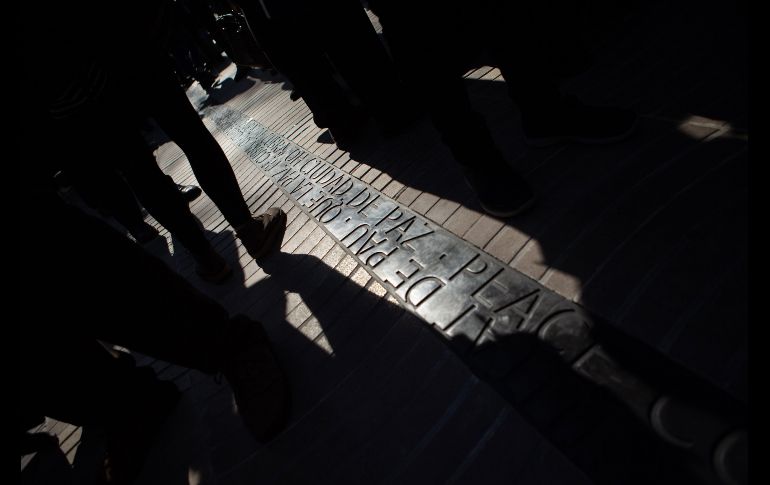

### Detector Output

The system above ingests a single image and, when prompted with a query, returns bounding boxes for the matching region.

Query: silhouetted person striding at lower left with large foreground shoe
[17,185,289,484]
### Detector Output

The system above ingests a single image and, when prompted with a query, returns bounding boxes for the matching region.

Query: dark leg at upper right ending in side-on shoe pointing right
[483,0,637,146]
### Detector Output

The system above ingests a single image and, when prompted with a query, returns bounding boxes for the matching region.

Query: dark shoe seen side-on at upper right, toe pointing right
[521,96,637,147]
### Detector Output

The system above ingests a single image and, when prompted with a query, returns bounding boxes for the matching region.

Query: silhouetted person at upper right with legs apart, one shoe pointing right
[368,0,636,217]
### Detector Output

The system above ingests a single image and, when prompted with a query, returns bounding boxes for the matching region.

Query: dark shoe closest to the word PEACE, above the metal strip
[465,166,535,218]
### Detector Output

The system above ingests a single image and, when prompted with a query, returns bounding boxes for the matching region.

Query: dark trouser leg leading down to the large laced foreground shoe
[20,190,228,372]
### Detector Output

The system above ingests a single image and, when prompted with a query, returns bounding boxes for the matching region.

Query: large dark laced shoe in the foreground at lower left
[222,315,289,442]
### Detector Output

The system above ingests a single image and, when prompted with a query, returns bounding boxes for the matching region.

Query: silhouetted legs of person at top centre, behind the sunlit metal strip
[236,0,407,148]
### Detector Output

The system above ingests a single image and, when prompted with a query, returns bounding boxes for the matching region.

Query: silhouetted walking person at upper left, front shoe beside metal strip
[25,2,286,282]
